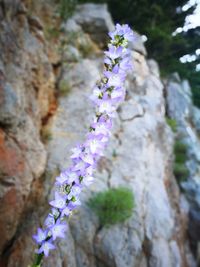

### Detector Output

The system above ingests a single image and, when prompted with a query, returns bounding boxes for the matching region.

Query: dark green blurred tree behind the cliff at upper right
[79,0,200,107]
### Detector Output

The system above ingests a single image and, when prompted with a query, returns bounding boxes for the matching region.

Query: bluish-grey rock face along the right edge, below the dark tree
[166,74,200,258]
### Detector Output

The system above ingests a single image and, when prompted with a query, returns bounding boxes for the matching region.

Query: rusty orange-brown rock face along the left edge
[0,1,54,265]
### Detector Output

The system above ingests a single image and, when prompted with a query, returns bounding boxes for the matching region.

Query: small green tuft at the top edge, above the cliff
[58,0,77,21]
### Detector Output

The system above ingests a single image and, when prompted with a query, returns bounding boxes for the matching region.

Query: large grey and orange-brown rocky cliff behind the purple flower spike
[0,0,199,267]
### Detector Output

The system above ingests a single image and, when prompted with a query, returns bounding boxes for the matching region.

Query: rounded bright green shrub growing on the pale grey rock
[88,187,135,226]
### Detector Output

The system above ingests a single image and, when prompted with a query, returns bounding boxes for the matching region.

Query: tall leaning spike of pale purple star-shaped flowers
[33,24,134,264]
